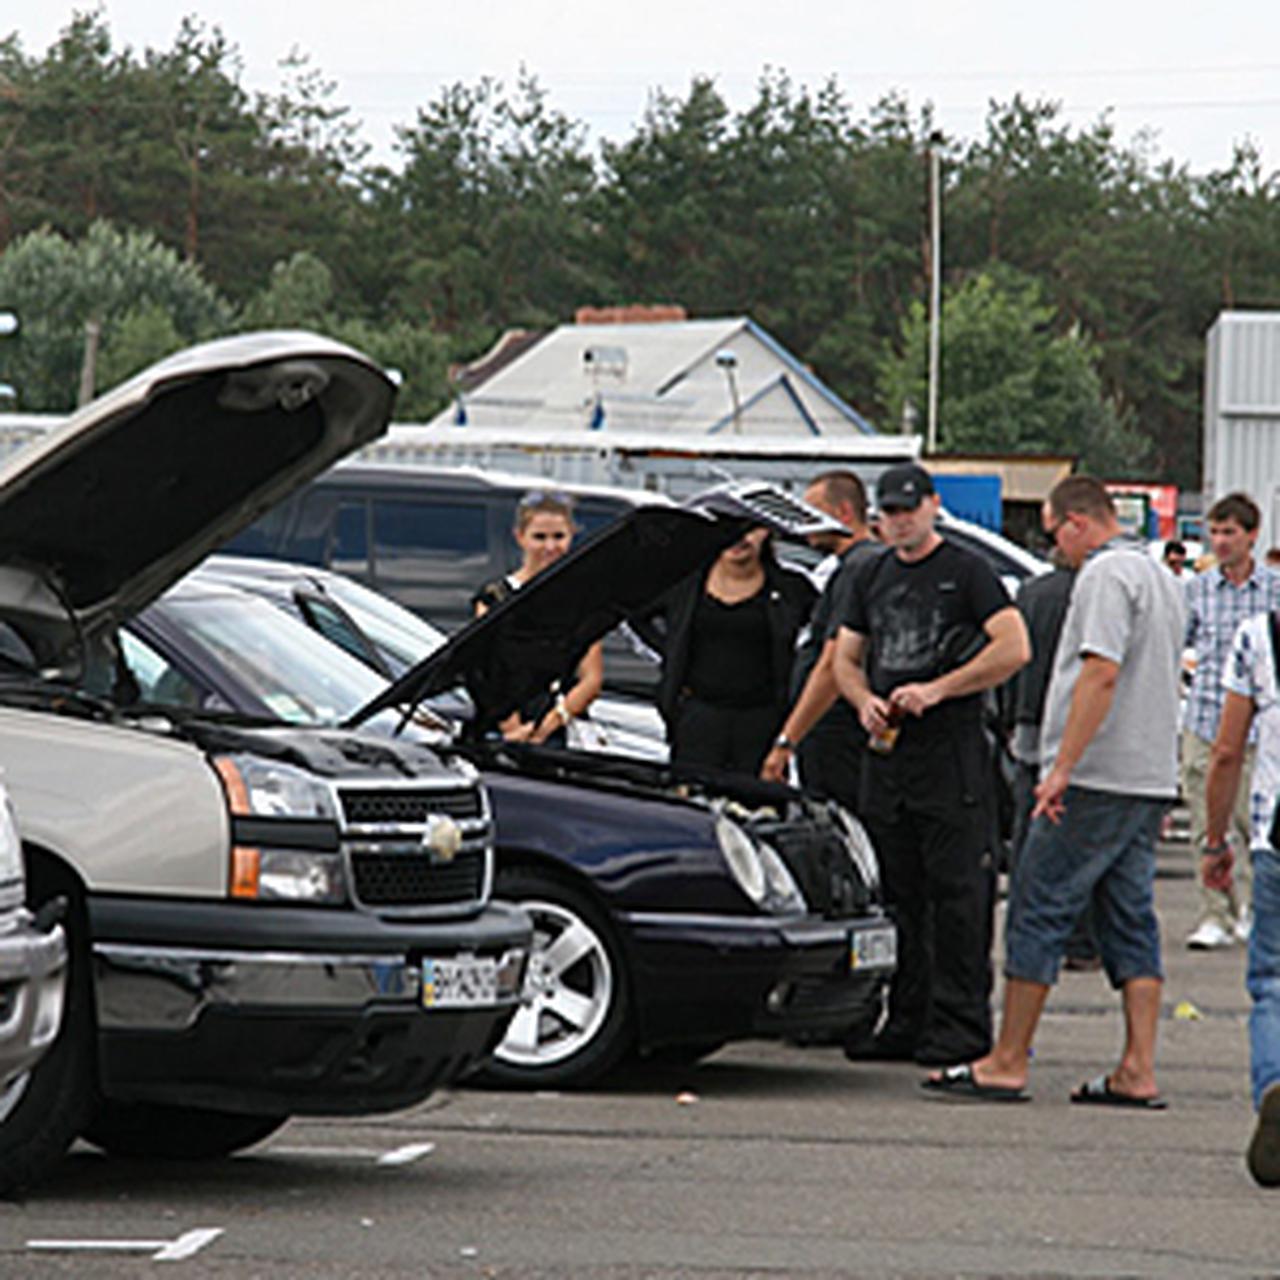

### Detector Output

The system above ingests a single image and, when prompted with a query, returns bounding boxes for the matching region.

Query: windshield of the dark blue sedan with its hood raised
[169,595,387,724]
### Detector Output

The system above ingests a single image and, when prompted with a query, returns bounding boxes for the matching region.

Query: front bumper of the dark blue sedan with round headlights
[625,911,893,1046]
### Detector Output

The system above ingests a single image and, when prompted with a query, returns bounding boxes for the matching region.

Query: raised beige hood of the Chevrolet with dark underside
[0,333,396,663]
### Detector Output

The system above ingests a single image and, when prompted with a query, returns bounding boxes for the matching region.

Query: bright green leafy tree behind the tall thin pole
[879,269,1147,476]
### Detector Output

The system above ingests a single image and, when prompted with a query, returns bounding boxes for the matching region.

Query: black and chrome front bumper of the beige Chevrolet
[90,899,531,1115]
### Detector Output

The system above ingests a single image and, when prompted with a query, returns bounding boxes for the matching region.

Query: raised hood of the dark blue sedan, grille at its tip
[348,483,844,726]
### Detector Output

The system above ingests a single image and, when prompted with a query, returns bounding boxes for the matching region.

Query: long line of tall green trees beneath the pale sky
[0,13,1280,488]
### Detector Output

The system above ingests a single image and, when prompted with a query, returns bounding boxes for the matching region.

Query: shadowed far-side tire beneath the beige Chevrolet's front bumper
[84,1102,288,1160]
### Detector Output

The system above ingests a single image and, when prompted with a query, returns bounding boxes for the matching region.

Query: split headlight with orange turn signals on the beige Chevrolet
[214,755,349,906]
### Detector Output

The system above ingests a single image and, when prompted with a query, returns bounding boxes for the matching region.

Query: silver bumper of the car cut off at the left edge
[0,908,67,1088]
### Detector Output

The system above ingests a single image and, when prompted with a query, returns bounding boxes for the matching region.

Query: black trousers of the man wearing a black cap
[860,718,996,1062]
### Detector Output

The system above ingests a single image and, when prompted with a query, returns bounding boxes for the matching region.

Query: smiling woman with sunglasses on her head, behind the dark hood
[471,490,604,746]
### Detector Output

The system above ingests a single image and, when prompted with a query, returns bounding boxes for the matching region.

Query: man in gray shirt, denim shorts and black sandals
[924,476,1183,1110]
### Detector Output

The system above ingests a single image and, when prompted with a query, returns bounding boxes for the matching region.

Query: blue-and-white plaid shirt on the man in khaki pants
[1183,564,1280,742]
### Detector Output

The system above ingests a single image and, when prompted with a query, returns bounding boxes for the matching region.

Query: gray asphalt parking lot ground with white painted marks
[0,845,1280,1280]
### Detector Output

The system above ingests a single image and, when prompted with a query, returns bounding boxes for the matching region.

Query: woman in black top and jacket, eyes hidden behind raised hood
[636,529,817,776]
